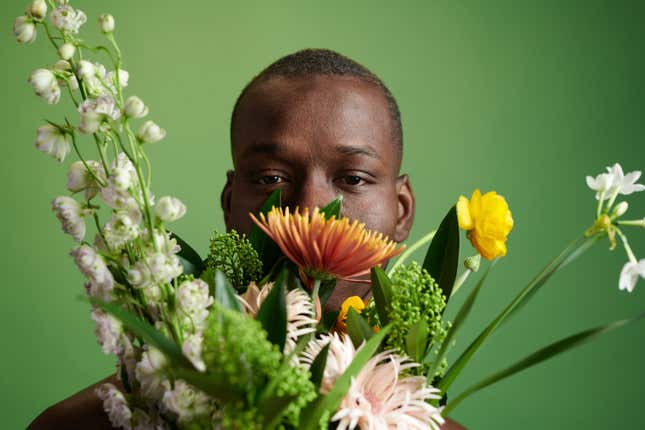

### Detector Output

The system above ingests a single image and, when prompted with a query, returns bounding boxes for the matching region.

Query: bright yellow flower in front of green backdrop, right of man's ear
[457,189,513,260]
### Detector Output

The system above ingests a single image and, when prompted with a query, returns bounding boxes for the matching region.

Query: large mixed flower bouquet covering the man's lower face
[14,0,645,429]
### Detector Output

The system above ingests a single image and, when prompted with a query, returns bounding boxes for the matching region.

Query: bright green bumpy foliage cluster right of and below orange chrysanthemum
[384,262,447,373]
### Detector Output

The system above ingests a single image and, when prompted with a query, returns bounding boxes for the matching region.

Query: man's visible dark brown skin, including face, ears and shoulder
[29,76,463,430]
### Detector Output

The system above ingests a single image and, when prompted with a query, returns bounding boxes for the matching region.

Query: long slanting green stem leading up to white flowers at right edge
[437,237,595,391]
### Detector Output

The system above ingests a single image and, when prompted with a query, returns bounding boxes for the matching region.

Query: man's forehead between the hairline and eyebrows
[232,75,397,166]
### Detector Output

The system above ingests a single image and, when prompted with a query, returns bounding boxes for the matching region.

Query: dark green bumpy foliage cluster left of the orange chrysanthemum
[206,230,262,292]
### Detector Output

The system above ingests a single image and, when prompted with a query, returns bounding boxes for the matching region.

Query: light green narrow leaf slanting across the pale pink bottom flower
[300,326,390,430]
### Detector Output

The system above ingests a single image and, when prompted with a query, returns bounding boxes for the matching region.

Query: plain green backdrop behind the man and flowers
[0,0,645,429]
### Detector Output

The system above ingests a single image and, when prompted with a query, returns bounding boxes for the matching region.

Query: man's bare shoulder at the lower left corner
[28,375,121,430]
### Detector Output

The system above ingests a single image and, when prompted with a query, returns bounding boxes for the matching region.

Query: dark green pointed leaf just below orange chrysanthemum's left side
[255,269,287,351]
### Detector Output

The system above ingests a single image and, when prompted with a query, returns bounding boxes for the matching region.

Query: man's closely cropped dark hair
[230,49,403,154]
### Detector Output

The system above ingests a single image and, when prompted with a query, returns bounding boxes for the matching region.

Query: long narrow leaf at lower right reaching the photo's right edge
[443,313,645,414]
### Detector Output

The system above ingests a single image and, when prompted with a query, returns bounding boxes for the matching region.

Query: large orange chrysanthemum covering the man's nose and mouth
[250,207,404,279]
